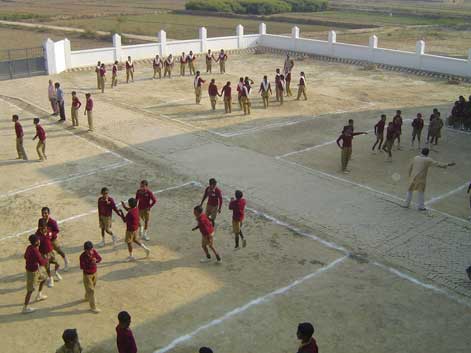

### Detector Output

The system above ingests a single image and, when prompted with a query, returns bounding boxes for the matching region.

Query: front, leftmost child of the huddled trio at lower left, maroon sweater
[23,234,47,314]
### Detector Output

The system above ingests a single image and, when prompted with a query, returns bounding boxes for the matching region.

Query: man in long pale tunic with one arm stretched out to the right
[403,148,456,211]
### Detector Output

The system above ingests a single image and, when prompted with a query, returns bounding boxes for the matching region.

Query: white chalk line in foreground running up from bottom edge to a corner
[154,256,348,353]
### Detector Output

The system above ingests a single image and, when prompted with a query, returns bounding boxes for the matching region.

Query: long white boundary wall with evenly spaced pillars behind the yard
[44,23,471,78]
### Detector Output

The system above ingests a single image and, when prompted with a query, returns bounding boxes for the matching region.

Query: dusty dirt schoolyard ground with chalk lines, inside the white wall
[0,54,471,353]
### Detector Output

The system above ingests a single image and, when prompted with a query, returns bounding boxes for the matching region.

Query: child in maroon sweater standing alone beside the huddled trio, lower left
[80,241,101,314]
